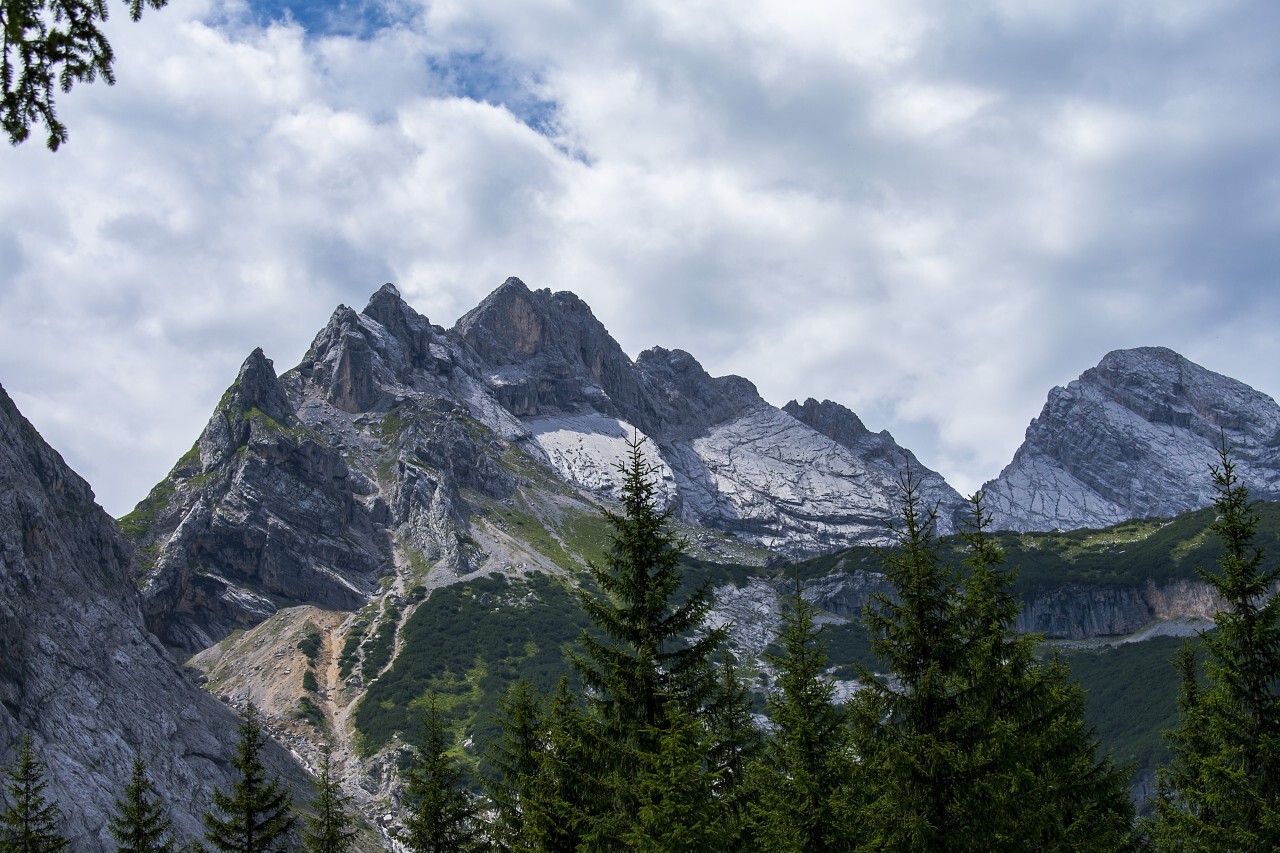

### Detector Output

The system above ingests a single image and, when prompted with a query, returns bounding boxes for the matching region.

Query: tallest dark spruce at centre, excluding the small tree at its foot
[571,438,742,849]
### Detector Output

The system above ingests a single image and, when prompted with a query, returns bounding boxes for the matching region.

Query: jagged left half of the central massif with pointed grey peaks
[135,284,519,653]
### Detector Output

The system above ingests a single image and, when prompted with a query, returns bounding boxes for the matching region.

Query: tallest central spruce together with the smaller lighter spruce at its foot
[571,439,739,849]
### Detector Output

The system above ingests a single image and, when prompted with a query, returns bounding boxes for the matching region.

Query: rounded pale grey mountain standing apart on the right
[983,347,1280,530]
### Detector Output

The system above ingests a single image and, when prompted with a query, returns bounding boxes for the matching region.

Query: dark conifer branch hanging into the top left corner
[0,0,166,151]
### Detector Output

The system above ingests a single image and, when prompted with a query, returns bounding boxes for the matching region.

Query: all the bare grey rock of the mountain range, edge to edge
[0,279,1280,839]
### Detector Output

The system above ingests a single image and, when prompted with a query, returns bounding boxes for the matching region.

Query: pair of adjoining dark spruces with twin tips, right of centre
[851,475,1134,850]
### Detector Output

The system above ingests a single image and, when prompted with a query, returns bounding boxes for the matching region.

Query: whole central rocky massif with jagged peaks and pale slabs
[129,278,960,653]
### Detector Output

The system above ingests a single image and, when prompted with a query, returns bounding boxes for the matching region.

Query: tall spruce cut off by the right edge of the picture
[1152,438,1280,850]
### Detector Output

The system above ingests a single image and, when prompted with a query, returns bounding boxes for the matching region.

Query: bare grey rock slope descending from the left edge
[0,388,308,850]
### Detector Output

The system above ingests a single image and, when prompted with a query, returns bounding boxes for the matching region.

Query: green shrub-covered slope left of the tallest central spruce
[355,575,588,752]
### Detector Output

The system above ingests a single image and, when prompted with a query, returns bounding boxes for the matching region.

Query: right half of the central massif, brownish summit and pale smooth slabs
[452,279,959,555]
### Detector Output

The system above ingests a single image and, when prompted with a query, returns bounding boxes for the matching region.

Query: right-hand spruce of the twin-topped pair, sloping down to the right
[951,494,1135,850]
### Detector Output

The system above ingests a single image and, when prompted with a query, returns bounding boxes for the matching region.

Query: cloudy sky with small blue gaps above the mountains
[0,0,1280,515]
